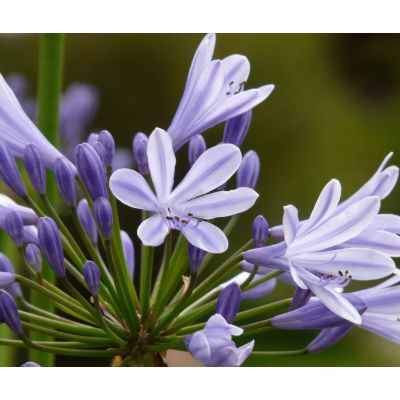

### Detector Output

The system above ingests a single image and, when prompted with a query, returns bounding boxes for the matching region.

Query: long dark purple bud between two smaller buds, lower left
[37,217,65,278]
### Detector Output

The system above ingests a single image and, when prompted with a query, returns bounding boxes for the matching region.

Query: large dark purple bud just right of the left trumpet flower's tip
[75,143,107,200]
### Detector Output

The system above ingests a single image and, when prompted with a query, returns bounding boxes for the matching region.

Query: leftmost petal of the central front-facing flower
[110,168,158,212]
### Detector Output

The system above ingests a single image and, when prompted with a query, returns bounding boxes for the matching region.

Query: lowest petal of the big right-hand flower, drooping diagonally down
[307,282,362,325]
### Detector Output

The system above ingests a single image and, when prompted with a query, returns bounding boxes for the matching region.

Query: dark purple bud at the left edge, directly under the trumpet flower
[0,140,27,197]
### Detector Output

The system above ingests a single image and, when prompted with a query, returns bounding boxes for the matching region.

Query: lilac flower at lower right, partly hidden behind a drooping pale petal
[272,276,400,352]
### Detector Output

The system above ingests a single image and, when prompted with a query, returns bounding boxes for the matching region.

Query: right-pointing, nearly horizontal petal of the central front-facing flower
[182,188,258,219]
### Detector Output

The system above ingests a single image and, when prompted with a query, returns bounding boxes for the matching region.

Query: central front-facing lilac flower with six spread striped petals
[110,128,258,253]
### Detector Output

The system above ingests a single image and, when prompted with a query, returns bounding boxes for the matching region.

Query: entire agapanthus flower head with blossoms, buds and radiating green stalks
[0,34,400,367]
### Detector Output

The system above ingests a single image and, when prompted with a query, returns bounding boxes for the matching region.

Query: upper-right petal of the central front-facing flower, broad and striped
[171,144,242,204]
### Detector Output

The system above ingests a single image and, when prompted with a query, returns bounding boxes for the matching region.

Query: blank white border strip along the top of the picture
[0,0,399,33]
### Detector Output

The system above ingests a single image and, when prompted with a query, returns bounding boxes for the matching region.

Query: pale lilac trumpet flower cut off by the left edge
[0,74,75,170]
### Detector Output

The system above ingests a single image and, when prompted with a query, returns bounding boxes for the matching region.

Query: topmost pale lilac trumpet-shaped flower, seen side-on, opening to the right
[168,34,274,150]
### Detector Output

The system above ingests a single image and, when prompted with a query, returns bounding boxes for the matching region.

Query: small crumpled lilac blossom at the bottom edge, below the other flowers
[184,314,254,367]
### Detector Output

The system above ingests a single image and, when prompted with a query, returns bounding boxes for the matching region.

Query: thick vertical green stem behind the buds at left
[29,33,64,367]
